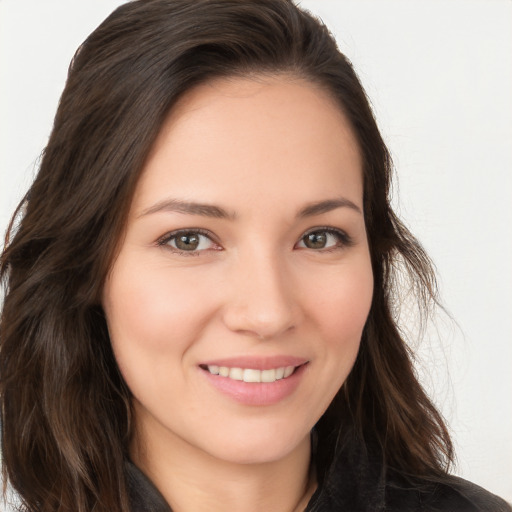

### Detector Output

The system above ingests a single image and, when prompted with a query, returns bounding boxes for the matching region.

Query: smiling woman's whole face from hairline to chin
[103,77,373,463]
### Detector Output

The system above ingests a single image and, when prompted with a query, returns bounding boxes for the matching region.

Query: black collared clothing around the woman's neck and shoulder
[126,436,512,512]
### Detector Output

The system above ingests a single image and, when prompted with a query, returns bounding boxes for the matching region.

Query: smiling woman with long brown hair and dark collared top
[0,0,509,511]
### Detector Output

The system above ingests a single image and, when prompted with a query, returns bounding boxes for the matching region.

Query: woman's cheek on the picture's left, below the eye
[103,255,216,366]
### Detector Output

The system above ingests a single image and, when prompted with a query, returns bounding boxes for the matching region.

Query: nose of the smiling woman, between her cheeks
[223,248,301,339]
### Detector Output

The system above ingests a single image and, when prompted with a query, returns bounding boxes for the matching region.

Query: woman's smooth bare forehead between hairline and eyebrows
[134,76,362,213]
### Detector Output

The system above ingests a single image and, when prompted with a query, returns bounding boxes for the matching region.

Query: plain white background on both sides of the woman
[0,0,512,501]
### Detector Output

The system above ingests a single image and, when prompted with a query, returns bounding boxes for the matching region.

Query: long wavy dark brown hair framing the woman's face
[0,0,452,512]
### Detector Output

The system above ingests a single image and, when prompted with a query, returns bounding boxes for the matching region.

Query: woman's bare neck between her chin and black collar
[131,412,315,512]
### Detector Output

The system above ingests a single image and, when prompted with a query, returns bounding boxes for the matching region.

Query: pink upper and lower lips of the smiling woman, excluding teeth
[199,358,309,406]
